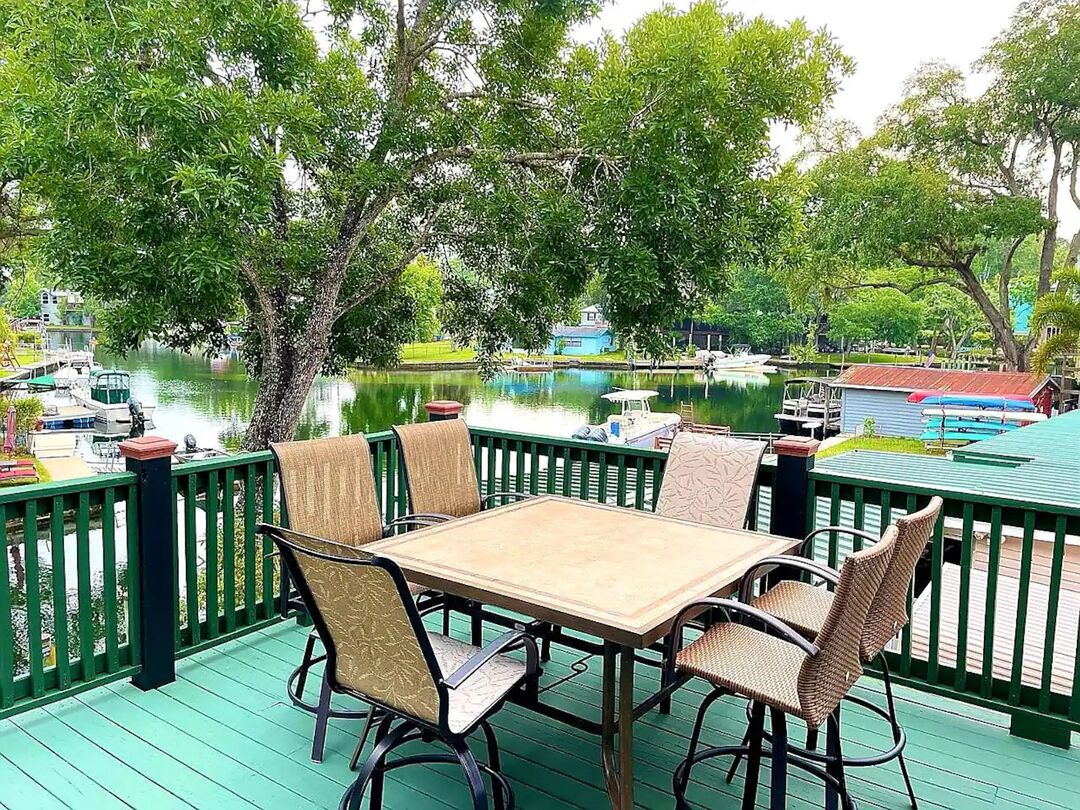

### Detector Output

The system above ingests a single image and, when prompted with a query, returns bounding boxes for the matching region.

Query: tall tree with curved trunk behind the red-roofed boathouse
[808,0,1080,368]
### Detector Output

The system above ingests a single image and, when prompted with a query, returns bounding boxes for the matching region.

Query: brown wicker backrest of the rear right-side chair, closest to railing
[862,496,942,661]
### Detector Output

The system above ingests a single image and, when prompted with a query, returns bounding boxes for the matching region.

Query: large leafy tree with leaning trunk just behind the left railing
[0,0,848,448]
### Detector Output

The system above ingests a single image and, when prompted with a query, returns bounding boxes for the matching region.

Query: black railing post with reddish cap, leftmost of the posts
[120,436,176,690]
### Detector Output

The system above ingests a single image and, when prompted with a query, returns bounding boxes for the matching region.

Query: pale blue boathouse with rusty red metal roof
[832,365,1057,437]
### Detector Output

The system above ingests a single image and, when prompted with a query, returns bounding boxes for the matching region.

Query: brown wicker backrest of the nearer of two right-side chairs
[798,526,897,727]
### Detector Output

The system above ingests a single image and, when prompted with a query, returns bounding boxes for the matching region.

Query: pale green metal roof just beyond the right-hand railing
[818,411,1080,509]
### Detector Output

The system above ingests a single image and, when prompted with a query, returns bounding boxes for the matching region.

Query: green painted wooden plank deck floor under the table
[0,622,1080,810]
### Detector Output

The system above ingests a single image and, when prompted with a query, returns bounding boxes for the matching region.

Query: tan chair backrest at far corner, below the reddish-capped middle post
[394,419,481,517]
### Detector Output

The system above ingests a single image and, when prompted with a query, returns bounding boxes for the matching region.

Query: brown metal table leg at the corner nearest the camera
[600,642,634,810]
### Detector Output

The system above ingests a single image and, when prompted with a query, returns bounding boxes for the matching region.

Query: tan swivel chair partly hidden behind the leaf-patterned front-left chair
[270,435,441,762]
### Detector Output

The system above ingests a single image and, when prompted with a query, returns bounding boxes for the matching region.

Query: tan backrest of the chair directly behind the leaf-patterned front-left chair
[270,435,382,545]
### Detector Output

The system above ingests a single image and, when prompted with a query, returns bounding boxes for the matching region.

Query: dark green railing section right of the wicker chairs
[808,468,1080,745]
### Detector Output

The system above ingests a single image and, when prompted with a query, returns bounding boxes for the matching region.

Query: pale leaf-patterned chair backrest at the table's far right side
[656,432,765,529]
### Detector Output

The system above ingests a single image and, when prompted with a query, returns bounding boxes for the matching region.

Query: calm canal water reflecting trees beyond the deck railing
[100,345,803,449]
